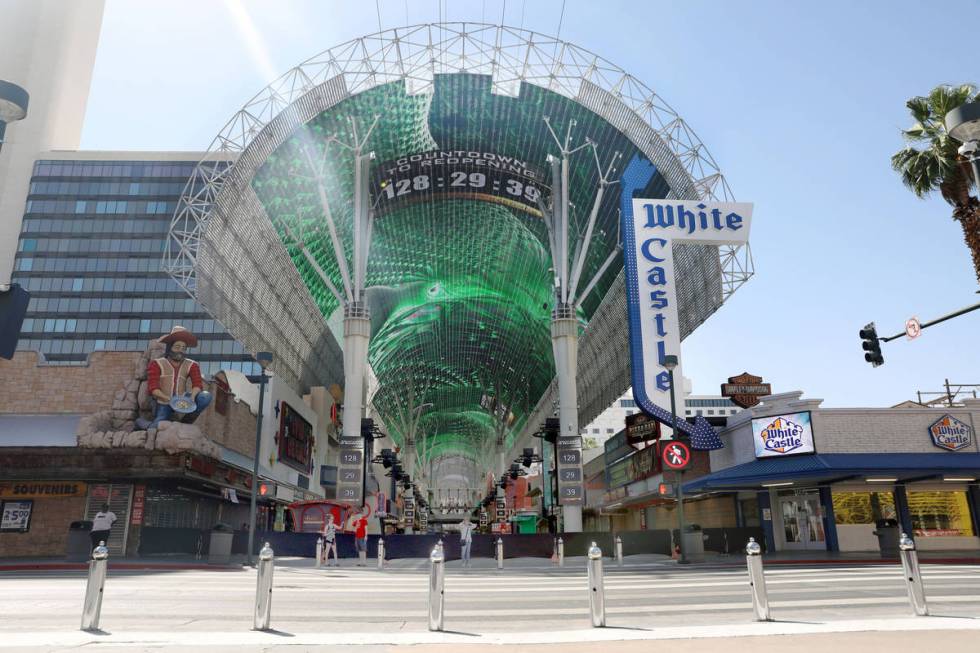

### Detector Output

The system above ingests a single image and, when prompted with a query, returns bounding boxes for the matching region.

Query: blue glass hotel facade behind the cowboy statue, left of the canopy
[13,160,258,375]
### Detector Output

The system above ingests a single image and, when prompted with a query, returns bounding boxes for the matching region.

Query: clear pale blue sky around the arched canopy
[82,0,980,406]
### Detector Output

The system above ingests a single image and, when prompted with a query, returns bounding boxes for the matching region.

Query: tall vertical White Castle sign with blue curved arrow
[620,155,752,449]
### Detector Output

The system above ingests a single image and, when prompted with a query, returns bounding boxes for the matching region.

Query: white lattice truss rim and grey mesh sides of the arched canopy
[164,23,754,398]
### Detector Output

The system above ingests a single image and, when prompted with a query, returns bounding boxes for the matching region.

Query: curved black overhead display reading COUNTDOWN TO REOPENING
[373,150,548,217]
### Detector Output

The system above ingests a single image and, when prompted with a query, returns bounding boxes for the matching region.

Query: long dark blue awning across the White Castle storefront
[684,453,980,494]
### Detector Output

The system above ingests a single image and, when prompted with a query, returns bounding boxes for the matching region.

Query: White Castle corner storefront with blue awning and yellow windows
[685,392,980,551]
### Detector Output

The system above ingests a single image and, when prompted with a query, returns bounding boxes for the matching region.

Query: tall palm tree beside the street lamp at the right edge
[892,84,980,282]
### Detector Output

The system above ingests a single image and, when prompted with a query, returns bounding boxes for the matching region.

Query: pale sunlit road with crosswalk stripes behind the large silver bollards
[0,561,980,652]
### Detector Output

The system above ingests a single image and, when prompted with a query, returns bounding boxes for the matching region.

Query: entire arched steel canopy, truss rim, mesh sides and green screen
[165,23,752,484]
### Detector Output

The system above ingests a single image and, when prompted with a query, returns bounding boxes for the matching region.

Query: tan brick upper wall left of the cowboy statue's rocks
[0,351,140,414]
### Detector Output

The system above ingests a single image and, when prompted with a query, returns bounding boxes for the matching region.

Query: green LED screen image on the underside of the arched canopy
[253,74,668,463]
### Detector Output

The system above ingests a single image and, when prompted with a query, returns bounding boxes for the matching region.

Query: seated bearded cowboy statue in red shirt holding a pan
[136,326,211,430]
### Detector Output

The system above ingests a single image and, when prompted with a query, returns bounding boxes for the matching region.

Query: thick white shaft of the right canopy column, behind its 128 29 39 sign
[551,304,582,533]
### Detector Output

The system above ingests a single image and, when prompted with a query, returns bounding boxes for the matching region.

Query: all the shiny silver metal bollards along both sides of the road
[82,533,929,631]
